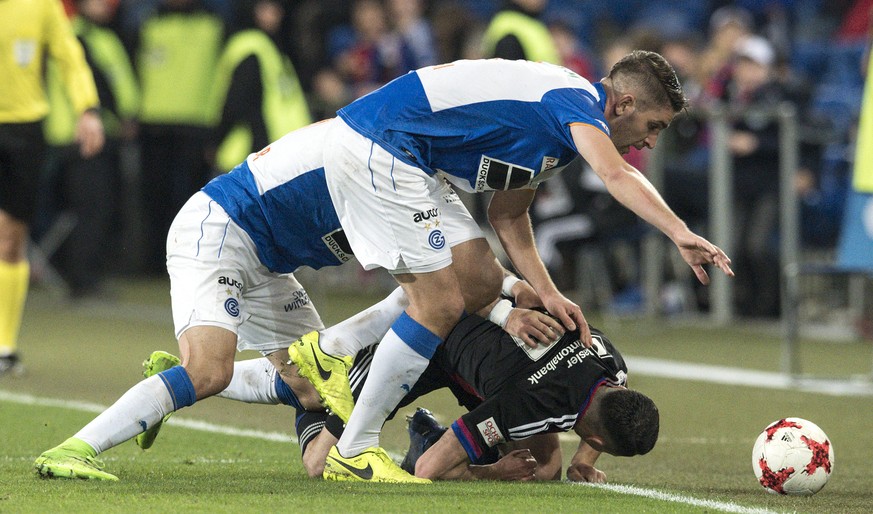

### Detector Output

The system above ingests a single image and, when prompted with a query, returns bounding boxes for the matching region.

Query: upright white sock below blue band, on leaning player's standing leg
[337,330,430,457]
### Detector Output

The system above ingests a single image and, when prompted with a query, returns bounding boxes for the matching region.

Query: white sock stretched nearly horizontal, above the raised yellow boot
[318,287,409,357]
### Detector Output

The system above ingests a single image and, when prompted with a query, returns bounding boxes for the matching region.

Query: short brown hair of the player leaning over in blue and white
[606,50,688,113]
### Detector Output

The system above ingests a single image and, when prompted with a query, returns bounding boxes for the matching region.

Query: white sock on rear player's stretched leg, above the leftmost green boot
[73,375,173,453]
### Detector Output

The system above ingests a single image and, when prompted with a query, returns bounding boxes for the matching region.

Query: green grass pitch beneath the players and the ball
[0,281,873,513]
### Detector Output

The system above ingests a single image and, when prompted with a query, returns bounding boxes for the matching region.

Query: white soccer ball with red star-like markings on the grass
[752,418,834,496]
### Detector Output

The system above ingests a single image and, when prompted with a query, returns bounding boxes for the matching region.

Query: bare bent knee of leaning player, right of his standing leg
[452,237,503,312]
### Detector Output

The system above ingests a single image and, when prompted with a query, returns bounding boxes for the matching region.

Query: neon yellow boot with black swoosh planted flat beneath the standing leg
[322,446,431,484]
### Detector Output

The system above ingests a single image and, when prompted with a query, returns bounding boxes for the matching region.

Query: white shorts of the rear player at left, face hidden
[167,192,324,355]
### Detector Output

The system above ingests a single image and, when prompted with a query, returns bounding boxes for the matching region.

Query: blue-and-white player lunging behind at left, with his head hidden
[35,121,503,480]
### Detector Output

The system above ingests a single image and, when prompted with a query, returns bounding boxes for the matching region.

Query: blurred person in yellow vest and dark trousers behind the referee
[40,0,139,298]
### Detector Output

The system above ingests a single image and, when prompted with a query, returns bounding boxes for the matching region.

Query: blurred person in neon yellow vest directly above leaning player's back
[482,0,561,64]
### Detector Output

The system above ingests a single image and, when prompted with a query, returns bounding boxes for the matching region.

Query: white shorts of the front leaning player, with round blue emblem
[324,118,485,274]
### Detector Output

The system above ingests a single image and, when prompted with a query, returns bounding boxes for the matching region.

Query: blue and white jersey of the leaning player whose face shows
[338,59,609,192]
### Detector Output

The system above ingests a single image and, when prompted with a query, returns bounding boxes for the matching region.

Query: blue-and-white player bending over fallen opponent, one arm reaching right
[289,51,733,481]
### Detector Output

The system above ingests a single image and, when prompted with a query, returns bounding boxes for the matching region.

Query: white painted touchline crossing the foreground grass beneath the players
[8,389,775,514]
